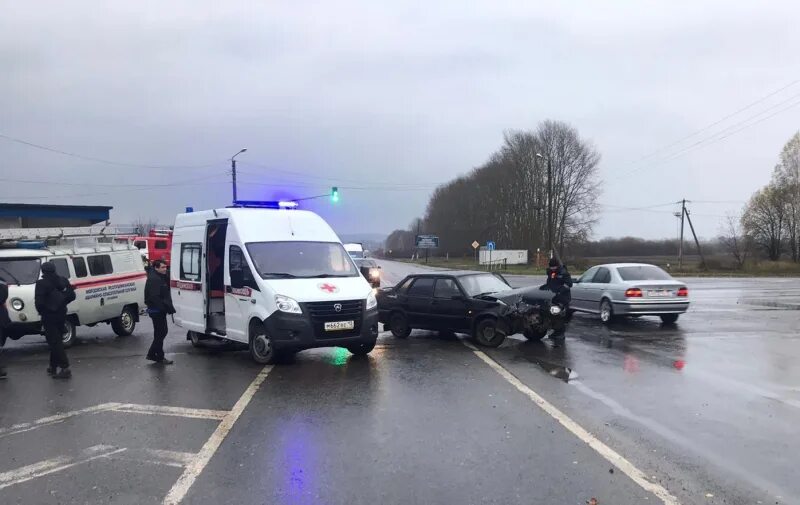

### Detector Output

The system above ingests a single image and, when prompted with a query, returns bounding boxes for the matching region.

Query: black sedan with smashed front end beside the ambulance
[377,271,512,347]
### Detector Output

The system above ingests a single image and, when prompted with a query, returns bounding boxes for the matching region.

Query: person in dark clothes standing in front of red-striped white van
[34,262,75,379]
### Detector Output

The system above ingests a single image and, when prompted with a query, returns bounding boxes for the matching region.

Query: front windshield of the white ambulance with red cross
[247,242,359,279]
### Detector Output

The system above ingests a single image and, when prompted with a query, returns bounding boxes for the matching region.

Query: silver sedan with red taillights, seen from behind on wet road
[571,263,689,324]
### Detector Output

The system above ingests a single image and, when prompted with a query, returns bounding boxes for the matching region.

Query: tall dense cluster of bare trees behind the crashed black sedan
[386,121,600,255]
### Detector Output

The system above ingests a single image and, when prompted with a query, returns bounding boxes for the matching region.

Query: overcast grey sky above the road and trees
[0,0,800,238]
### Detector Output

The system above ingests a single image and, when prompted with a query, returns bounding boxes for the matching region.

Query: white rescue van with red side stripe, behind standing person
[0,241,147,347]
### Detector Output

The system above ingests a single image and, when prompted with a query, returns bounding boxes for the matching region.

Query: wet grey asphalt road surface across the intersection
[0,262,800,505]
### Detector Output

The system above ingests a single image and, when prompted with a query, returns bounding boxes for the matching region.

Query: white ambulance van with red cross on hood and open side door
[170,207,378,363]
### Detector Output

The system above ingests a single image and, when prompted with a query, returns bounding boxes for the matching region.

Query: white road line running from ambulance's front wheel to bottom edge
[164,365,272,505]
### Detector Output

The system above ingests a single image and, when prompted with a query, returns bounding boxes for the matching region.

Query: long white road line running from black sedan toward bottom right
[464,342,680,505]
